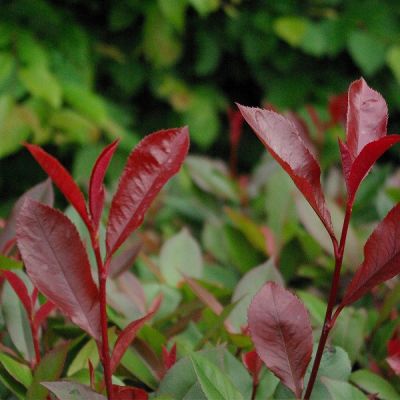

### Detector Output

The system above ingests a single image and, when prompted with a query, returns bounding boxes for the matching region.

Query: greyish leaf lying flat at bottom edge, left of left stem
[42,381,106,400]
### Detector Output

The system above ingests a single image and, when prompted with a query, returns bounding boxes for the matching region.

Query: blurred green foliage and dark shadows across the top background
[0,0,400,212]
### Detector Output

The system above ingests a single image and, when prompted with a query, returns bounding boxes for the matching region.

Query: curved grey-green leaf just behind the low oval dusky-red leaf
[229,260,284,332]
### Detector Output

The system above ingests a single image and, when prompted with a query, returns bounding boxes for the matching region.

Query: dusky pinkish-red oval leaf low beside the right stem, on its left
[248,282,313,398]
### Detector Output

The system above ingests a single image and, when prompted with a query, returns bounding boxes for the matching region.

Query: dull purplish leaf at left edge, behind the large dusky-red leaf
[0,179,54,254]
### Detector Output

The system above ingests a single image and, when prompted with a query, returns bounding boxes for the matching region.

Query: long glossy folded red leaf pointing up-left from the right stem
[238,105,335,237]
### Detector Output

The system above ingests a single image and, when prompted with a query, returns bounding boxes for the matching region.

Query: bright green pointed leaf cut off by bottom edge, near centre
[191,354,243,400]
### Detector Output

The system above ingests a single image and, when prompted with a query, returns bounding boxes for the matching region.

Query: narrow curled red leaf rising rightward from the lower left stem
[110,296,162,373]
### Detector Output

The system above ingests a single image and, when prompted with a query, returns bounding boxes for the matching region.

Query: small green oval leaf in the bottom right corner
[350,369,400,400]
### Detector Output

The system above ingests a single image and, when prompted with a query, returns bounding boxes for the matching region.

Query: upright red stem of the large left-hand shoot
[92,237,113,400]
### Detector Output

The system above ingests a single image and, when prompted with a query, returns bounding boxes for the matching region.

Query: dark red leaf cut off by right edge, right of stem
[339,204,400,310]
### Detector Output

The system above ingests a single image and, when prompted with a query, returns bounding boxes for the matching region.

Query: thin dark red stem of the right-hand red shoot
[304,200,353,400]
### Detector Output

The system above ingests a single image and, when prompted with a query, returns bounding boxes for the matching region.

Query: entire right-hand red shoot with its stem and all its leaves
[239,78,400,400]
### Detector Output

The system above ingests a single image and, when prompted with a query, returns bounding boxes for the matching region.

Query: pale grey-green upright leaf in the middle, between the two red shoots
[160,229,203,286]
